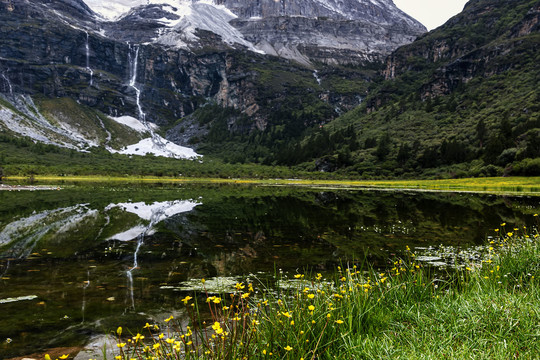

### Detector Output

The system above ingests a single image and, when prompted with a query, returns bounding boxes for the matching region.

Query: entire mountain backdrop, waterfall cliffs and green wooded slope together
[0,0,540,177]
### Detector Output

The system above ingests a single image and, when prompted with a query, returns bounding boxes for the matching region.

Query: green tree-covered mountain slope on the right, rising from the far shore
[292,0,540,177]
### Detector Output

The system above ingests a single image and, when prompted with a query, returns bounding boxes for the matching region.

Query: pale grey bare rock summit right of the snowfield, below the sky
[216,0,426,65]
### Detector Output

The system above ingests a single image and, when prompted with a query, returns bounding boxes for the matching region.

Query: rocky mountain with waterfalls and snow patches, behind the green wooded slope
[0,0,425,162]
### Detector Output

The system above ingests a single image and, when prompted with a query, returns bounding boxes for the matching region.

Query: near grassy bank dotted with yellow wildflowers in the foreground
[90,221,540,360]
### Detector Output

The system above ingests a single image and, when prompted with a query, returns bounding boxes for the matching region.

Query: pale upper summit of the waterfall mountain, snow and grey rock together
[85,0,426,65]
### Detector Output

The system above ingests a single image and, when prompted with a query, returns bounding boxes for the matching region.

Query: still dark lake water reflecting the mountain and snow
[0,184,540,359]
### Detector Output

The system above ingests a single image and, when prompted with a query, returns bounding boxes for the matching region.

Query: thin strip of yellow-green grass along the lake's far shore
[4,175,540,195]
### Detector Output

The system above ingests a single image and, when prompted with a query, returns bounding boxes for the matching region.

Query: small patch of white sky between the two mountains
[393,0,467,30]
